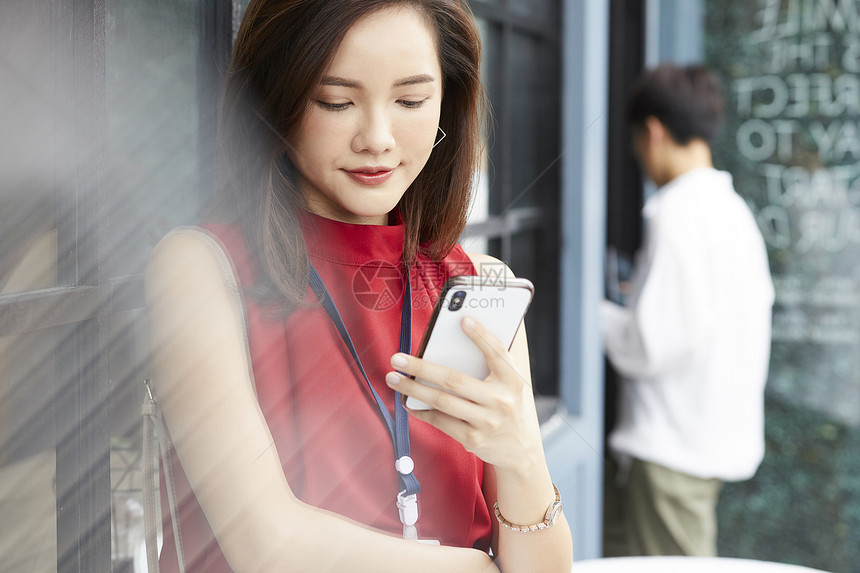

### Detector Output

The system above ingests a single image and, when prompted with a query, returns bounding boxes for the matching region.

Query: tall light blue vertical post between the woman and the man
[559,0,609,559]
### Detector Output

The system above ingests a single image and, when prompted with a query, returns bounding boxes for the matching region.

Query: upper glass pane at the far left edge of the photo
[0,0,62,293]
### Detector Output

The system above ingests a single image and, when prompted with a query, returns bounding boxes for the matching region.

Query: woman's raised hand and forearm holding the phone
[386,298,573,572]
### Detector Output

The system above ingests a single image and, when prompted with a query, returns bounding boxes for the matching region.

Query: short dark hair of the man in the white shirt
[627,64,723,145]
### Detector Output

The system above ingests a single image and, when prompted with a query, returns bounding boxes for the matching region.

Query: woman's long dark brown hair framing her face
[210,0,484,313]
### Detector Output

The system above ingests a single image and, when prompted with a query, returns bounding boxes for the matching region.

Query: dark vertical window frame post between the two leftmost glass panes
[55,0,111,573]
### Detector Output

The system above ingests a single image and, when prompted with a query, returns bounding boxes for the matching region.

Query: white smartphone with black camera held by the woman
[406,276,534,410]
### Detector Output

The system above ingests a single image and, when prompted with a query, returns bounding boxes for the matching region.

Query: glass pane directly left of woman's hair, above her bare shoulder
[106,0,202,276]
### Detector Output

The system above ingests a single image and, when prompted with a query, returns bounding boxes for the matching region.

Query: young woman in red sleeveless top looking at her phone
[146,0,571,573]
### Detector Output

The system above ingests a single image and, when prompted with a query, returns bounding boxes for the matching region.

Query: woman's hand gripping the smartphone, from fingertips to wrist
[386,318,543,471]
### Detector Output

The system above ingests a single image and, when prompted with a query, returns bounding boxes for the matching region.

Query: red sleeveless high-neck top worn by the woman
[160,215,491,573]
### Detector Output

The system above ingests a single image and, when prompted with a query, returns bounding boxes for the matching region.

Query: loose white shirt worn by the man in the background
[601,168,774,481]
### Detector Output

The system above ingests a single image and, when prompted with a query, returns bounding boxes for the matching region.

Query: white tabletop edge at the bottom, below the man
[573,557,821,573]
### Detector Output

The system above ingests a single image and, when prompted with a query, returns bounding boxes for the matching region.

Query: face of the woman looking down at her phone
[288,8,444,225]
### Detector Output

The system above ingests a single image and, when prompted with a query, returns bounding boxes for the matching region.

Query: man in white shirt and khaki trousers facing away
[601,64,774,556]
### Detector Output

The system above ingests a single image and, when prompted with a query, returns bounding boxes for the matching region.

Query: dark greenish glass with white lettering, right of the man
[704,0,860,571]
